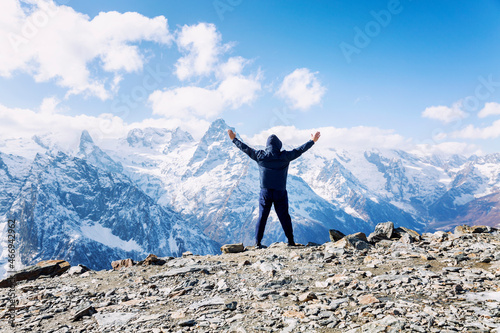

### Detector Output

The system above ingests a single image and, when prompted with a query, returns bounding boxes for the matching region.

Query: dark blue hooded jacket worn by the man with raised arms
[233,134,314,190]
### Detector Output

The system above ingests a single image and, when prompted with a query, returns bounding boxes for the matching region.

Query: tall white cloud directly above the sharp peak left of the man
[152,23,261,120]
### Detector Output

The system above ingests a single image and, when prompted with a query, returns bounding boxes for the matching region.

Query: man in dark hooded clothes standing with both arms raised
[227,130,320,249]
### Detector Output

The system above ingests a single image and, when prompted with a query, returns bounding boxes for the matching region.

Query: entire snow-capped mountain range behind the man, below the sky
[0,119,500,276]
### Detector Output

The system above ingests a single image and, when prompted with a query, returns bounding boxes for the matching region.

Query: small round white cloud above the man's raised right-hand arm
[276,68,326,110]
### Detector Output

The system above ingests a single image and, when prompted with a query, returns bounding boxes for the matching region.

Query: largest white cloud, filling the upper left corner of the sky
[0,0,172,99]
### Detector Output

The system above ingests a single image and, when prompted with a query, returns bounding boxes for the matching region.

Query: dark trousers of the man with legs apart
[255,188,293,244]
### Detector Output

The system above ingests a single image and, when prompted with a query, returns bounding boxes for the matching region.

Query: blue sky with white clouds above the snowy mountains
[0,0,500,153]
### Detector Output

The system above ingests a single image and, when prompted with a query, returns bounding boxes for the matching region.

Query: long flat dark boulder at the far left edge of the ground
[0,260,71,288]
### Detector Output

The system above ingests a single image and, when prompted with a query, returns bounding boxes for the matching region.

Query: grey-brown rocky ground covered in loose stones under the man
[0,224,500,333]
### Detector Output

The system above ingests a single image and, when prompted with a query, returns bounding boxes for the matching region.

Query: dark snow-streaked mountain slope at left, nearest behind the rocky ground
[2,152,218,269]
